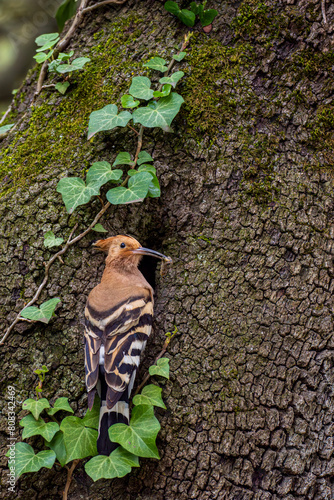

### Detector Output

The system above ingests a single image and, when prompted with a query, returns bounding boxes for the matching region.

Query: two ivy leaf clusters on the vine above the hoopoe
[57,51,186,214]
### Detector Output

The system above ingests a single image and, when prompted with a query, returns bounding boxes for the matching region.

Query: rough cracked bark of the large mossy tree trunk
[0,0,334,500]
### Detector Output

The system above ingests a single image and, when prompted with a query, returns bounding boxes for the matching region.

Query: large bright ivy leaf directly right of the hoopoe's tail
[109,404,160,459]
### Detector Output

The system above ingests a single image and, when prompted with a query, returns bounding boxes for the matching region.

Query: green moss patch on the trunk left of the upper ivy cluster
[0,15,146,193]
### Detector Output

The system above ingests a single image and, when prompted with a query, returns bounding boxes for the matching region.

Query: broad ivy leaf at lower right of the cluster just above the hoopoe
[107,172,152,205]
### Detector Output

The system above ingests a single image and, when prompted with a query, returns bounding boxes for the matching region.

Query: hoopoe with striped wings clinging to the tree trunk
[84,235,171,456]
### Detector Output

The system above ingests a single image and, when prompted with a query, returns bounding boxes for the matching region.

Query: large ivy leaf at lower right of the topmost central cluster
[133,92,184,131]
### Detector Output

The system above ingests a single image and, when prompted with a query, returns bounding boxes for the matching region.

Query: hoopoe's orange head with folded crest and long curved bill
[93,235,171,266]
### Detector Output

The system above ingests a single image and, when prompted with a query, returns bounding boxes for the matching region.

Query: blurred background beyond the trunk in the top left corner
[0,0,63,113]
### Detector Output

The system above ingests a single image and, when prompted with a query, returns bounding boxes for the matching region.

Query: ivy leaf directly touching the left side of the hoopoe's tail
[60,417,98,463]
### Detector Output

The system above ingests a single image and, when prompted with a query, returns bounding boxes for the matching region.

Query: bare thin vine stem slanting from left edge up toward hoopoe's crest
[0,197,111,345]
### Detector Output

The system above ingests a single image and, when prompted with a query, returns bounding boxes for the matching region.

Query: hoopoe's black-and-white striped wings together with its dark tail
[85,290,153,455]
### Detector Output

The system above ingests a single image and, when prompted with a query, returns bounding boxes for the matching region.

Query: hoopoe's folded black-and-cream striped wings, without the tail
[85,290,153,408]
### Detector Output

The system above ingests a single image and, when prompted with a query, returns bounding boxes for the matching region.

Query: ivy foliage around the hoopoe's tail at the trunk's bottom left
[7,358,169,481]
